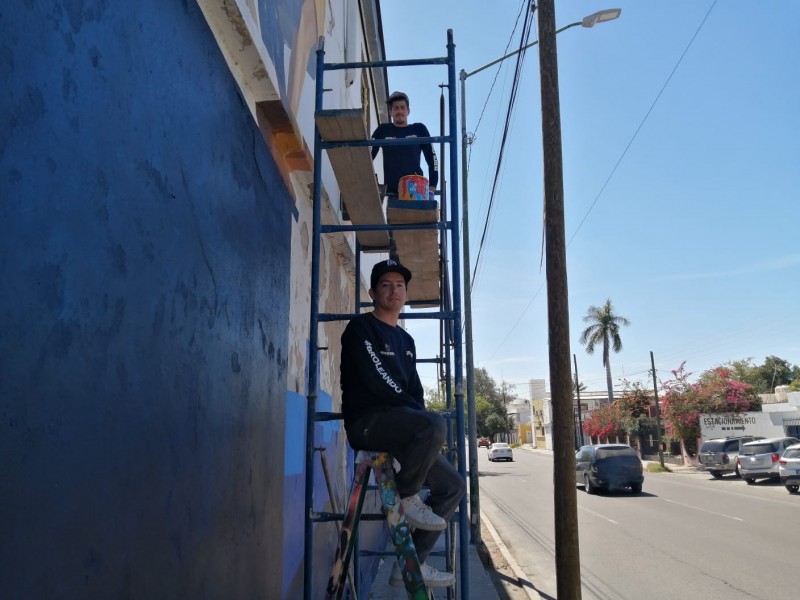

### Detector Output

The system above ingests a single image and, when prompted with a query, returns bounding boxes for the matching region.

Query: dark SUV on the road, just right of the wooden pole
[575,444,644,494]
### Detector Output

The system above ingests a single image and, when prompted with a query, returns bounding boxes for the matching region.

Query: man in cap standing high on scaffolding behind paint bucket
[372,92,439,198]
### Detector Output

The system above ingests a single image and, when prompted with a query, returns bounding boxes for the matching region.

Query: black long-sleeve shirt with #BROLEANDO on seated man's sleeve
[341,313,425,427]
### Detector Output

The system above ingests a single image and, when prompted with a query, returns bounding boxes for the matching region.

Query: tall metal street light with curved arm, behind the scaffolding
[459,8,622,543]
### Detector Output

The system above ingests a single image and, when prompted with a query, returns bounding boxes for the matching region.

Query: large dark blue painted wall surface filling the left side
[0,0,294,599]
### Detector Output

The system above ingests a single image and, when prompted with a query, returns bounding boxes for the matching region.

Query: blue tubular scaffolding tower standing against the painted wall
[303,30,470,600]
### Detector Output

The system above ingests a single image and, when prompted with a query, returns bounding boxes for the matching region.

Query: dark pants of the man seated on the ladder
[347,408,466,561]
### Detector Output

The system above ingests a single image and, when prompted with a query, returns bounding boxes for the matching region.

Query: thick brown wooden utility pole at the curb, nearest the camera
[537,0,581,600]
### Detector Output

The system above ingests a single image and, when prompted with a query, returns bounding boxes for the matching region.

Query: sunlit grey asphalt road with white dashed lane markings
[478,448,800,600]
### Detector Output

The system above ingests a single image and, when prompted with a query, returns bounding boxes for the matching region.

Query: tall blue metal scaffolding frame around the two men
[303,30,470,600]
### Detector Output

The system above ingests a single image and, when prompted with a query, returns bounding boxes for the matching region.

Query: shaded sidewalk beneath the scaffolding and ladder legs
[368,534,499,600]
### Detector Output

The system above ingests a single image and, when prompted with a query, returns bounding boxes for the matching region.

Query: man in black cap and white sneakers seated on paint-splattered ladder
[341,259,466,587]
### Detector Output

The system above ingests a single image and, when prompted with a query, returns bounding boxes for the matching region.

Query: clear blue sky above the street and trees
[381,0,800,397]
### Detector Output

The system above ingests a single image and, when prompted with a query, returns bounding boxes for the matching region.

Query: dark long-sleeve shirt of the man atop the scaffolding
[372,123,439,194]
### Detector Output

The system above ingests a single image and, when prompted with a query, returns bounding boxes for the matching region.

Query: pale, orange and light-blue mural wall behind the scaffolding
[197,0,385,598]
